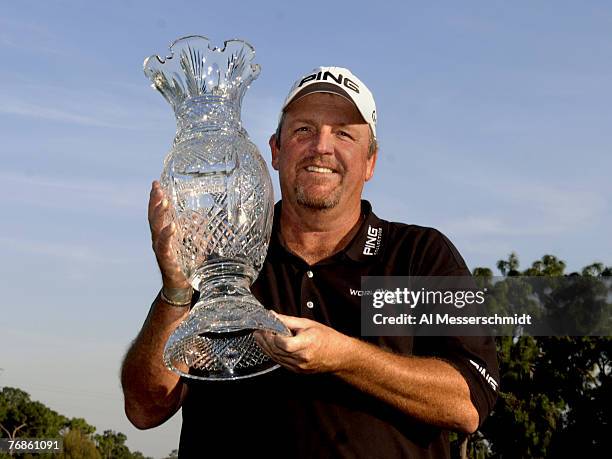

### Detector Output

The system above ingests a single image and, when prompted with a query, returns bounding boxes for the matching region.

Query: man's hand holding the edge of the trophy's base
[254,312,352,373]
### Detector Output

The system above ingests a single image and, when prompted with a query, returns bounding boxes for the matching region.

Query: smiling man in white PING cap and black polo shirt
[122,67,498,458]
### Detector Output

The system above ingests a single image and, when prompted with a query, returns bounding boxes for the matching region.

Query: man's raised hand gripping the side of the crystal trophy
[148,180,190,288]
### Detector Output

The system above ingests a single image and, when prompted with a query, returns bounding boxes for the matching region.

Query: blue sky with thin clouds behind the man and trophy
[0,1,612,456]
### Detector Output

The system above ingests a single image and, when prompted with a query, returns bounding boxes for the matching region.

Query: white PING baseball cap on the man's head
[279,67,376,138]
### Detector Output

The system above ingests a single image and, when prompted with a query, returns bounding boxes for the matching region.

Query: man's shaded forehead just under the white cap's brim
[285,92,367,126]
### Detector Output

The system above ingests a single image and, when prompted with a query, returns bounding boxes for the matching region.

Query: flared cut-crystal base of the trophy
[164,296,291,381]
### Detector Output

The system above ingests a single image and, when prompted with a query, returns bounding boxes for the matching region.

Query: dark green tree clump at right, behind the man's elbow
[468,253,612,458]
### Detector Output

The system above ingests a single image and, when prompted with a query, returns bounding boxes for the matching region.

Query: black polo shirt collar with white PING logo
[268,199,387,263]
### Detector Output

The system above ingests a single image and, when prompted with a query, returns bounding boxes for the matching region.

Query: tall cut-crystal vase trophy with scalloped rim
[144,36,290,380]
